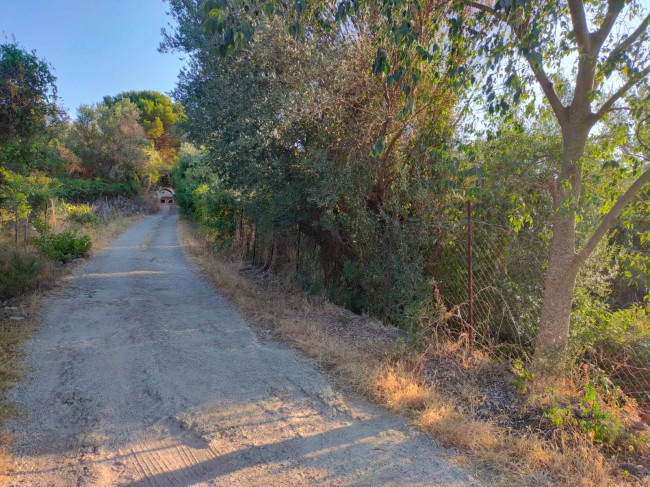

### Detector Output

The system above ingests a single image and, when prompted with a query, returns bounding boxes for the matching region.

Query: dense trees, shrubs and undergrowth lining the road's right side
[163,0,650,485]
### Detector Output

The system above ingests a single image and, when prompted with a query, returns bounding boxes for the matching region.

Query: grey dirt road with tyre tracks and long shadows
[6,209,475,487]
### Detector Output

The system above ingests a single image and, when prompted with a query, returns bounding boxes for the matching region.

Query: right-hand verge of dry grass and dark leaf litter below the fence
[179,221,645,487]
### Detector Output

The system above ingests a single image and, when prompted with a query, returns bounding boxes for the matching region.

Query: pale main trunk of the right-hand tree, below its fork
[535,124,589,369]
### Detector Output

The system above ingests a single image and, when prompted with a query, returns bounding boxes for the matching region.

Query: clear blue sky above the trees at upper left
[0,0,183,117]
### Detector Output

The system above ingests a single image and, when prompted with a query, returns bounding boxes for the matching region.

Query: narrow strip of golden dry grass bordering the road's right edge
[179,221,650,487]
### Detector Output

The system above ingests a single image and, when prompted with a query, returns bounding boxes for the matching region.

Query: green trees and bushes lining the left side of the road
[0,42,184,467]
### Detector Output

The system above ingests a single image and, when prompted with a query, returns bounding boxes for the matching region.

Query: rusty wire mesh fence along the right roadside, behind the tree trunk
[246,202,650,415]
